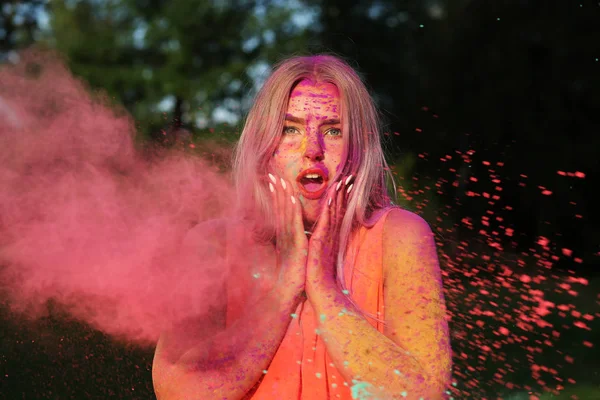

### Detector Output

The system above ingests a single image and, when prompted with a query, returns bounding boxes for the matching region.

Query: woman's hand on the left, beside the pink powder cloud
[268,174,308,298]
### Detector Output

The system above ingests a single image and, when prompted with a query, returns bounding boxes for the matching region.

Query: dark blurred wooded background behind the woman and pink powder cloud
[0,0,600,399]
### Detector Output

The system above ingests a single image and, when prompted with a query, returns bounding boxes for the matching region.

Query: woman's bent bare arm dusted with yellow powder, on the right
[307,210,451,400]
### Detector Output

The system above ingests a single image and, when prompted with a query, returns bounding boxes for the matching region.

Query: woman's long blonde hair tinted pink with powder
[232,55,396,320]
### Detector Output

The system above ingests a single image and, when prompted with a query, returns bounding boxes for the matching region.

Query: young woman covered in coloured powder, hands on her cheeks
[153,55,451,400]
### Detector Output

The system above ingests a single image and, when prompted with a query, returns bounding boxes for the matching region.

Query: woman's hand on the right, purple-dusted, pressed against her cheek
[306,175,353,292]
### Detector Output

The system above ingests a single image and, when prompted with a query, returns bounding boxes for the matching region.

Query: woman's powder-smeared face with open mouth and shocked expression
[273,80,346,229]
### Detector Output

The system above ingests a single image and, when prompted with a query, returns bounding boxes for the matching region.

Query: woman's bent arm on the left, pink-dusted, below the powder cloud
[152,284,300,400]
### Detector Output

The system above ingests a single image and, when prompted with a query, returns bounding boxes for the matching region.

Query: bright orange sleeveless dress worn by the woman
[229,208,391,400]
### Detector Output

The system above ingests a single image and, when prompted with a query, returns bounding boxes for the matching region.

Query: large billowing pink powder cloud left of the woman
[0,53,264,344]
